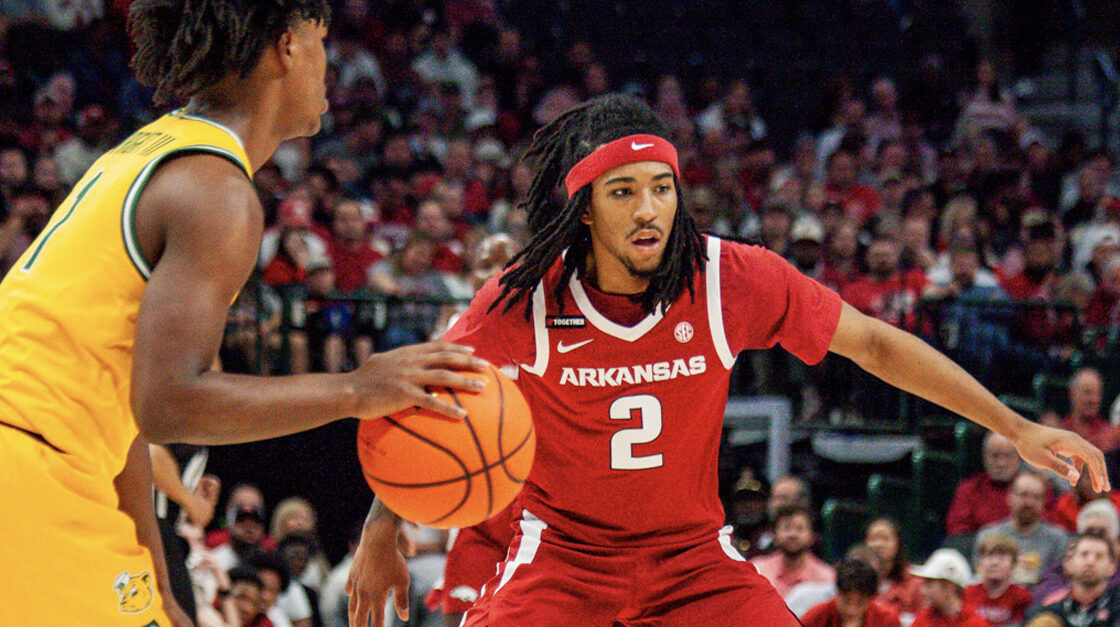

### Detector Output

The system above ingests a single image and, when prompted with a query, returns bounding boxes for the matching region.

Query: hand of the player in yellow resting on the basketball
[347,341,487,419]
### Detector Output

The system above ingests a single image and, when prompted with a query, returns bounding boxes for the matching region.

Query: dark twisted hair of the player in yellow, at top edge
[129,0,330,104]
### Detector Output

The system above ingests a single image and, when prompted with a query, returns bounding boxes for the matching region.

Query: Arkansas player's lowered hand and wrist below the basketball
[346,498,410,627]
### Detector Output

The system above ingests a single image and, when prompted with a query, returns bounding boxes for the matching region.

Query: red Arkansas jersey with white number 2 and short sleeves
[445,236,841,546]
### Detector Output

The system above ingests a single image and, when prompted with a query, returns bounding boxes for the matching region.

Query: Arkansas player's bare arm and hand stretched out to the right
[829,303,1109,492]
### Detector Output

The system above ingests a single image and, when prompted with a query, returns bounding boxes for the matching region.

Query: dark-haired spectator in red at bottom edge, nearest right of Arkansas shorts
[801,558,899,627]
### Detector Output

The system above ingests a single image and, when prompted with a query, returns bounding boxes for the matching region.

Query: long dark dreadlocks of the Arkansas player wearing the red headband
[489,95,707,319]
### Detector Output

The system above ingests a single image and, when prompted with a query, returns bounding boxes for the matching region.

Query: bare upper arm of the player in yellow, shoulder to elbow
[132,163,262,420]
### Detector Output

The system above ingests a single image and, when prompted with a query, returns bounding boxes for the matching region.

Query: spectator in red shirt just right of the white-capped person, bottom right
[964,535,1030,627]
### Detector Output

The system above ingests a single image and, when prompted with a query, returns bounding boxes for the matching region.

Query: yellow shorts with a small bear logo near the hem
[0,423,170,627]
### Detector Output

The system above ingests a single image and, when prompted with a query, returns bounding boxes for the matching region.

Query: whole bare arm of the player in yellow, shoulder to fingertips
[131,155,485,444]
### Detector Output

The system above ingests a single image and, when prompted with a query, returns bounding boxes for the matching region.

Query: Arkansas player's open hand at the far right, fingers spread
[1011,421,1112,493]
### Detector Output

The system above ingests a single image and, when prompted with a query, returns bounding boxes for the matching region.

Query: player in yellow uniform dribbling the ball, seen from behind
[0,0,484,627]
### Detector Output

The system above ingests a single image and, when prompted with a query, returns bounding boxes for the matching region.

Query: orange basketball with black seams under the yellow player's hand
[357,366,536,528]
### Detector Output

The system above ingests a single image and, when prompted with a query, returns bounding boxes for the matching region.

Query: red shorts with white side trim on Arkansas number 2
[463,512,800,627]
